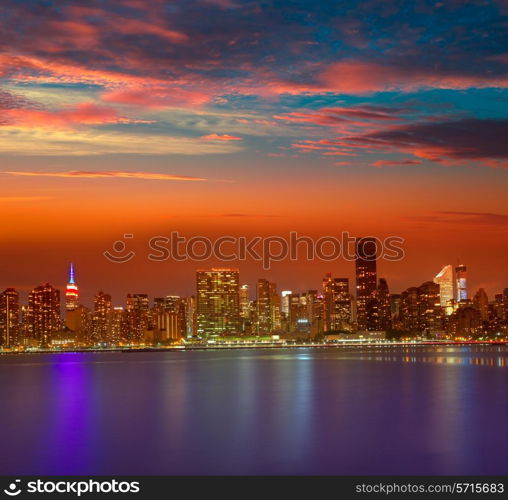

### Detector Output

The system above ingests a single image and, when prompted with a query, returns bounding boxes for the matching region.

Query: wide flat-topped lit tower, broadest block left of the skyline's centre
[196,268,240,337]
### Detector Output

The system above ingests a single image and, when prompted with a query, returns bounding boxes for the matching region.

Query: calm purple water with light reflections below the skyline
[0,347,508,475]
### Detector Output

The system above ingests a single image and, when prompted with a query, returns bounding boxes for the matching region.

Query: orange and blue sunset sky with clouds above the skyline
[0,0,508,305]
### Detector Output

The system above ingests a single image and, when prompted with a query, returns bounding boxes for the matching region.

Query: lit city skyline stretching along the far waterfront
[0,254,508,348]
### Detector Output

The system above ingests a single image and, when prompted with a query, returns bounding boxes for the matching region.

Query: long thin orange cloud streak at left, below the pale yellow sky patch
[0,170,208,182]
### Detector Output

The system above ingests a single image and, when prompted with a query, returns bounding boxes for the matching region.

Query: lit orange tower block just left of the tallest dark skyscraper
[323,273,352,332]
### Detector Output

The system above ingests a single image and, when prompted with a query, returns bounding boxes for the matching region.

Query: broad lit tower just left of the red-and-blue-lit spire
[27,283,62,346]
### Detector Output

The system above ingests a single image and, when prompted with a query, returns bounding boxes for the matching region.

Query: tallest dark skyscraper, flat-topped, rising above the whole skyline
[356,238,377,330]
